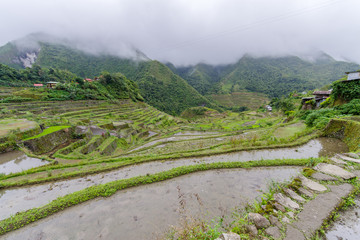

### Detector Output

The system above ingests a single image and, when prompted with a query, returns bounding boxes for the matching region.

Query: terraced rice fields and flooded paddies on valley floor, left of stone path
[0,85,357,239]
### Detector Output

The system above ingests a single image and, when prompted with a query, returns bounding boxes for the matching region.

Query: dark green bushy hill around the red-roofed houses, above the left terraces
[0,64,143,102]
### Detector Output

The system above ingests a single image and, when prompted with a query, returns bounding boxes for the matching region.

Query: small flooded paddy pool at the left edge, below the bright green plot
[0,151,48,174]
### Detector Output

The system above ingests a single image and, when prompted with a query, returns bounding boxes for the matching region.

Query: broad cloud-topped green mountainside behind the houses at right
[221,56,359,97]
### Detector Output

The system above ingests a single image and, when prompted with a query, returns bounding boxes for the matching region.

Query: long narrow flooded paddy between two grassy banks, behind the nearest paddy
[0,138,347,220]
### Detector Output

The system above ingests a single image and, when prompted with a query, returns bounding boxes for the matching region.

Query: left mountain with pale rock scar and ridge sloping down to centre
[0,34,216,114]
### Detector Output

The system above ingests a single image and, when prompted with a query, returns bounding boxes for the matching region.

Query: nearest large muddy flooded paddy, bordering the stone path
[4,167,299,240]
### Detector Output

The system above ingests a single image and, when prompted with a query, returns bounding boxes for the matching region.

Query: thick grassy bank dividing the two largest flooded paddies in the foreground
[0,158,316,235]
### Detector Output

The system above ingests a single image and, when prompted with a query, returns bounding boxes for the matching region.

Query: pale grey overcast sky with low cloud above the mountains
[0,0,360,65]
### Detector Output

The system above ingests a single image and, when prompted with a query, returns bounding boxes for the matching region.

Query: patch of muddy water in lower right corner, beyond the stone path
[326,196,360,240]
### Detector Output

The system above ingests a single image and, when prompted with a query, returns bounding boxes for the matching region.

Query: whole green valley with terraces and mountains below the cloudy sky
[0,34,360,240]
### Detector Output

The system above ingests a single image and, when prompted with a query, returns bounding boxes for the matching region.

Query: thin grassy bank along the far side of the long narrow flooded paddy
[0,132,321,189]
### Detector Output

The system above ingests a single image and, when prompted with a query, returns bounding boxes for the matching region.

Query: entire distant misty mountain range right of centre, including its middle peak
[176,53,360,97]
